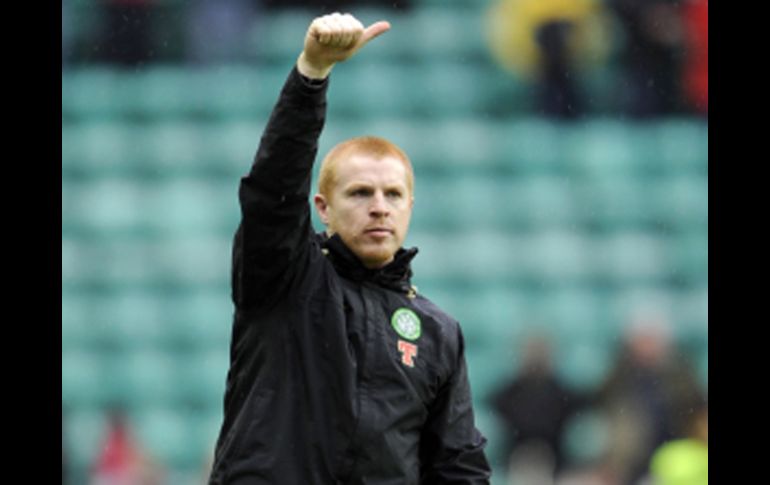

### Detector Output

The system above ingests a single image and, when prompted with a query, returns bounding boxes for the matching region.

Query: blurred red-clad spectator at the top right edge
[683,0,709,115]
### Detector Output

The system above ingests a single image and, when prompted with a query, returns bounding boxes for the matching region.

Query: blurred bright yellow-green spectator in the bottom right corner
[650,399,708,485]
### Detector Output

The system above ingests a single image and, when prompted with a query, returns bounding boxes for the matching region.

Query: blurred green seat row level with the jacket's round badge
[62,282,708,352]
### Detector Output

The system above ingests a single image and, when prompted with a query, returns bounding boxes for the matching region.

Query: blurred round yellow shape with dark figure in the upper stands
[488,0,609,119]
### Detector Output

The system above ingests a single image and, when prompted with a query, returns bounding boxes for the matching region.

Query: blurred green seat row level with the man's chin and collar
[62,229,708,287]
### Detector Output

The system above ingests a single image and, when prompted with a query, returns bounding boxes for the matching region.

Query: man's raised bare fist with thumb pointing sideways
[297,13,390,79]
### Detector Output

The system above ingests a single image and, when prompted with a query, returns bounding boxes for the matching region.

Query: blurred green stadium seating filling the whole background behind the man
[62,0,708,484]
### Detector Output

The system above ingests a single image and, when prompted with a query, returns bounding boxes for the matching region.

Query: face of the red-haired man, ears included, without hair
[315,154,414,268]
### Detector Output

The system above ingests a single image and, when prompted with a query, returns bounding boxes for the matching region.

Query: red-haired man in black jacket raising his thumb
[210,14,490,485]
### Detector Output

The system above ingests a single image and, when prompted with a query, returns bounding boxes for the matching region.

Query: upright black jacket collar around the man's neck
[318,232,418,293]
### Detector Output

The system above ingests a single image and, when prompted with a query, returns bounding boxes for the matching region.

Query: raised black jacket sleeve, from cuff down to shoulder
[232,66,328,309]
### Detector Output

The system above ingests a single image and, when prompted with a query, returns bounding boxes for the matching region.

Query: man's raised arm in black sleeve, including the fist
[232,13,390,309]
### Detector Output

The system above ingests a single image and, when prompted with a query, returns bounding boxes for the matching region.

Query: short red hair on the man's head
[318,136,414,198]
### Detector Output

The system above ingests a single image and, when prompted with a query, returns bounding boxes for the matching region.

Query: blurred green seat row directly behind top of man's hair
[62,115,708,178]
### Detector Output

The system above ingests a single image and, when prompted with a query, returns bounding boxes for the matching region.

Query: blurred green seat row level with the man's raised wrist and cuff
[62,56,624,121]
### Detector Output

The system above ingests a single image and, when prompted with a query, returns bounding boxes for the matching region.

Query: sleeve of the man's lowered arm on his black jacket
[420,330,491,485]
